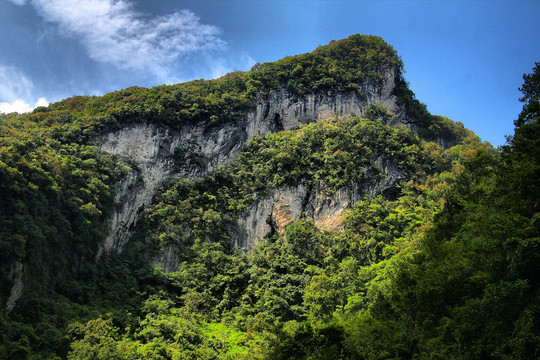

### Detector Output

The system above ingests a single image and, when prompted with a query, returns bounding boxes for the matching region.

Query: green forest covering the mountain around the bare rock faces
[0,35,540,359]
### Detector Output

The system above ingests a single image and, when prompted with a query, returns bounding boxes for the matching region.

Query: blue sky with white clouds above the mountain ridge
[0,0,540,146]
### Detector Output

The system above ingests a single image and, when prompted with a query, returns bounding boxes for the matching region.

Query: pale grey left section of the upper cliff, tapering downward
[99,123,246,250]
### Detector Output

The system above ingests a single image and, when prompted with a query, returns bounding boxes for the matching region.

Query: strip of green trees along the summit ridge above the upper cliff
[9,34,452,143]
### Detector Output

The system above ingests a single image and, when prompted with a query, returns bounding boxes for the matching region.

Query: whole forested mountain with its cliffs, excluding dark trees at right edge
[0,35,537,359]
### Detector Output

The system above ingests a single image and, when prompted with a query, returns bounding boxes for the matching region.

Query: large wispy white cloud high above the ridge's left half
[28,0,225,79]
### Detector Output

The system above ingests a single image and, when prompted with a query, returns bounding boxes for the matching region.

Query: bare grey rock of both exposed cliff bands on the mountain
[98,70,407,253]
